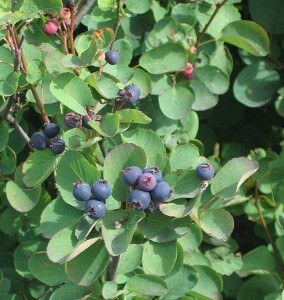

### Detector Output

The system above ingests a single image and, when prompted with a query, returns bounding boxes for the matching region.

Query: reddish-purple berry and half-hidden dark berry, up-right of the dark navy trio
[64,111,98,129]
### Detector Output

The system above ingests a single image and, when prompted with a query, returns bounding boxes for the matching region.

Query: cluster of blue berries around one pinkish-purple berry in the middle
[123,166,172,211]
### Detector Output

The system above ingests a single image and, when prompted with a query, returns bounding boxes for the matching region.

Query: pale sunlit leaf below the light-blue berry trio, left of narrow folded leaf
[46,224,80,264]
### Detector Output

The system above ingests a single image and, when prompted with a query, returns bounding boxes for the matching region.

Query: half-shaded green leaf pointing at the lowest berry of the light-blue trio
[40,197,83,238]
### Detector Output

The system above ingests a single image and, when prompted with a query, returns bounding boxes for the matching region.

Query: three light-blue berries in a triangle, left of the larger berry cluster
[73,179,111,219]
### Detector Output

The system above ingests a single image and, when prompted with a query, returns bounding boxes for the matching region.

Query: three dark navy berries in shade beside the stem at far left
[30,123,65,155]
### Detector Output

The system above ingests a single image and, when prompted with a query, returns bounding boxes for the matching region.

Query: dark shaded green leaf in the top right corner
[249,0,284,34]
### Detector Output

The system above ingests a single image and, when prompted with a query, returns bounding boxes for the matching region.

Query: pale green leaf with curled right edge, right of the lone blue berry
[211,157,258,198]
